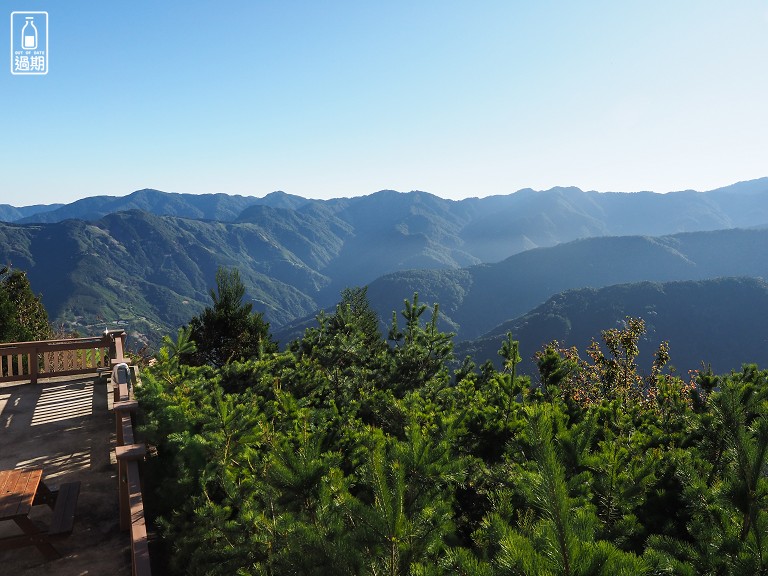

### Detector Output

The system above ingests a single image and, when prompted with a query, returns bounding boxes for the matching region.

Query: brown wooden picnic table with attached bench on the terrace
[0,469,60,560]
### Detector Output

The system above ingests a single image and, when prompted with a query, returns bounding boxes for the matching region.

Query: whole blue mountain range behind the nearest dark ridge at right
[0,178,768,374]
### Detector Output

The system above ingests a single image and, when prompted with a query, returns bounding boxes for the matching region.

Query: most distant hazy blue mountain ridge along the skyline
[9,178,768,266]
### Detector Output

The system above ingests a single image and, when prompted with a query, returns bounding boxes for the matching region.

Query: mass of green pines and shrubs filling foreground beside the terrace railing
[137,291,768,576]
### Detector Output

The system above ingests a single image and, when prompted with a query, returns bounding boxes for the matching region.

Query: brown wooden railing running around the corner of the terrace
[0,330,151,576]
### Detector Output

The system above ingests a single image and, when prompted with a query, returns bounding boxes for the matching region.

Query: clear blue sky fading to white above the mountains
[0,0,768,206]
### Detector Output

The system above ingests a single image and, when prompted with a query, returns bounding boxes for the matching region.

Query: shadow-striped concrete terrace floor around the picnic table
[0,377,131,576]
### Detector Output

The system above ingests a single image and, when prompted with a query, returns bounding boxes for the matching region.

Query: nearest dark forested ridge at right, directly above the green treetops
[456,278,768,378]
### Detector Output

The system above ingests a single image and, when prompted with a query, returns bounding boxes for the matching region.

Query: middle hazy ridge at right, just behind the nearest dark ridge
[368,229,768,340]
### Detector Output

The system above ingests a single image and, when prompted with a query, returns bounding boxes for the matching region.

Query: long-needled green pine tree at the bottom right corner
[649,365,768,576]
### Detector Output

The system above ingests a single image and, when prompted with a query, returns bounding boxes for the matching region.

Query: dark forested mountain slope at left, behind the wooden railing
[0,211,328,343]
